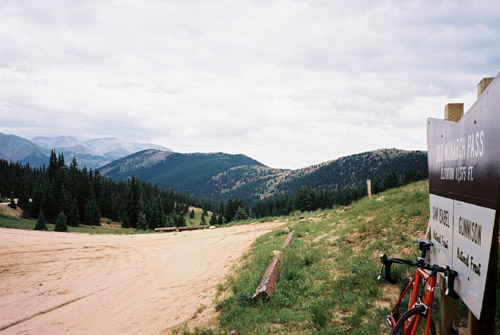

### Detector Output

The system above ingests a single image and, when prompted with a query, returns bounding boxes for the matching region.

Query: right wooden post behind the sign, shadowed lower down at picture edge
[467,78,499,335]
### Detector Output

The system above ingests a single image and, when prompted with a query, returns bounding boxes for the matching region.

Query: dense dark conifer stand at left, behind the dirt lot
[0,150,213,230]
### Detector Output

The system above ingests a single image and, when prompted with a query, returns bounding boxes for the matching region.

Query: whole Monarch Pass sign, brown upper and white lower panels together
[427,77,500,334]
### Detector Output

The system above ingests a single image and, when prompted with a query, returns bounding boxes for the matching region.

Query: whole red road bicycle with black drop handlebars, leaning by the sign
[378,238,459,335]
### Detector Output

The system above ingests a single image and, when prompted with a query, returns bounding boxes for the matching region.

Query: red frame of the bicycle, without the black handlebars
[388,267,437,335]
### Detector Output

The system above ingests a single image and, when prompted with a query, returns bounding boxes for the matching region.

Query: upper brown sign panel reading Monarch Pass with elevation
[427,78,500,210]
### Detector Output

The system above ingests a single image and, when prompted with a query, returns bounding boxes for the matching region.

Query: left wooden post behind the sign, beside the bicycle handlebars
[439,103,464,335]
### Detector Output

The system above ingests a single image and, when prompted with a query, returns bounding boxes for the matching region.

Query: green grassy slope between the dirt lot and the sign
[181,182,498,334]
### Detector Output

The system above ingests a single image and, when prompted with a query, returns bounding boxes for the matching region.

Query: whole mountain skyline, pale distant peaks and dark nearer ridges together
[0,133,428,202]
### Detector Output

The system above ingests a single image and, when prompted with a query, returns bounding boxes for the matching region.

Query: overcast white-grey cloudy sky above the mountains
[0,0,500,169]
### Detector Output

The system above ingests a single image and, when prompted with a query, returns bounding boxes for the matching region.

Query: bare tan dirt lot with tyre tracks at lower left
[0,222,281,335]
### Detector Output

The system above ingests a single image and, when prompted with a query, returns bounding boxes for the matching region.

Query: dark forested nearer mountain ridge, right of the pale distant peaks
[99,149,428,202]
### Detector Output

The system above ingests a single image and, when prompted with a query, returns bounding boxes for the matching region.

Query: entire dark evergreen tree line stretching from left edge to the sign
[0,150,426,231]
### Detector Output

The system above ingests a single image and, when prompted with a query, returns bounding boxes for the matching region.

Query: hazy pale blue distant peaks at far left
[0,133,171,169]
